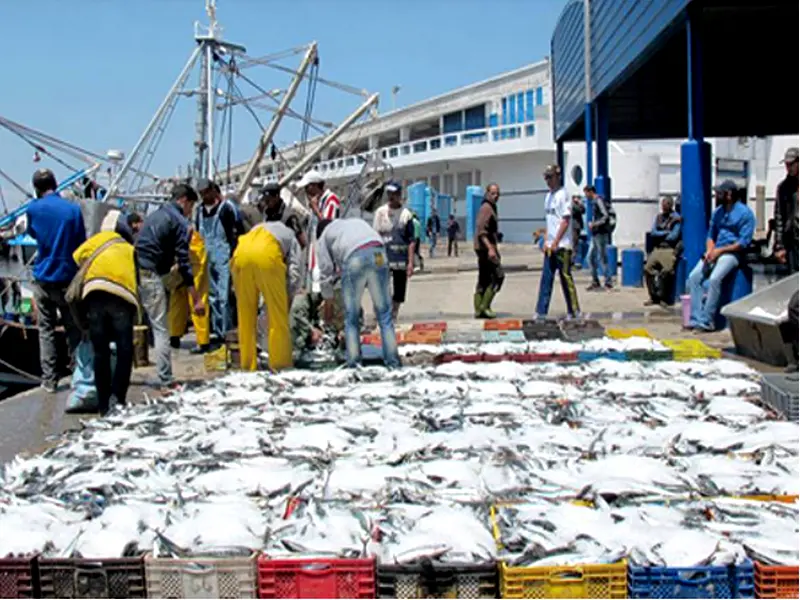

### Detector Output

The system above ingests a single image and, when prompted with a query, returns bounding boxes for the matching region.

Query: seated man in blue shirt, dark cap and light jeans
[688,180,756,331]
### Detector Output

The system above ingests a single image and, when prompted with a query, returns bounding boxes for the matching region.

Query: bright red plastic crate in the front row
[258,556,375,598]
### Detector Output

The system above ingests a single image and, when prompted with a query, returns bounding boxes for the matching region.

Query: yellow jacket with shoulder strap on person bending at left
[72,231,139,307]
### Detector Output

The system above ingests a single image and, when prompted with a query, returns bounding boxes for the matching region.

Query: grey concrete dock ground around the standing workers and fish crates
[0,245,773,464]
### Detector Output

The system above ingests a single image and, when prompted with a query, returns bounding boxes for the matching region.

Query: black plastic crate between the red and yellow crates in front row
[377,561,498,598]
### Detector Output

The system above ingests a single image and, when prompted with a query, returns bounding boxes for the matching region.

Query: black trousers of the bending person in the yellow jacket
[84,291,136,413]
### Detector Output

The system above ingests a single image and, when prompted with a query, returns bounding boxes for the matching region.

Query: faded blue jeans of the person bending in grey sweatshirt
[342,247,400,368]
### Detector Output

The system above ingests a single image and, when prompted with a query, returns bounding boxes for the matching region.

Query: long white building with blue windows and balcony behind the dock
[227,60,798,245]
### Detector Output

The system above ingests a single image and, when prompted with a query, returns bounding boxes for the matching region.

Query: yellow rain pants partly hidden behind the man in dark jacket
[168,231,211,346]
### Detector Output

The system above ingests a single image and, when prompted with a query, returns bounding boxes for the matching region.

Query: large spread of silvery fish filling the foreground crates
[0,340,800,566]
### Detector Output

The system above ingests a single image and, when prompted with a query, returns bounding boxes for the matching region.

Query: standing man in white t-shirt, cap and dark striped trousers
[536,165,580,319]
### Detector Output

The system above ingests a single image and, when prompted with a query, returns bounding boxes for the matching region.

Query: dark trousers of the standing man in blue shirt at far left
[33,281,81,385]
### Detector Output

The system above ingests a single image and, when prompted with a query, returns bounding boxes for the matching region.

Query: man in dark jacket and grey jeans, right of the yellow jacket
[136,184,205,387]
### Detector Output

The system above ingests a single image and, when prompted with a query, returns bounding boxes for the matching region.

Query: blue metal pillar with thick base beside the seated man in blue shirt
[677,12,711,278]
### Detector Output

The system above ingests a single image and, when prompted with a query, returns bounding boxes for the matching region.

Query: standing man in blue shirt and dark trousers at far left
[26,169,86,393]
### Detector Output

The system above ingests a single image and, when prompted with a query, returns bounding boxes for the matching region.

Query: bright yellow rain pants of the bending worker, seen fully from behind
[231,227,292,371]
